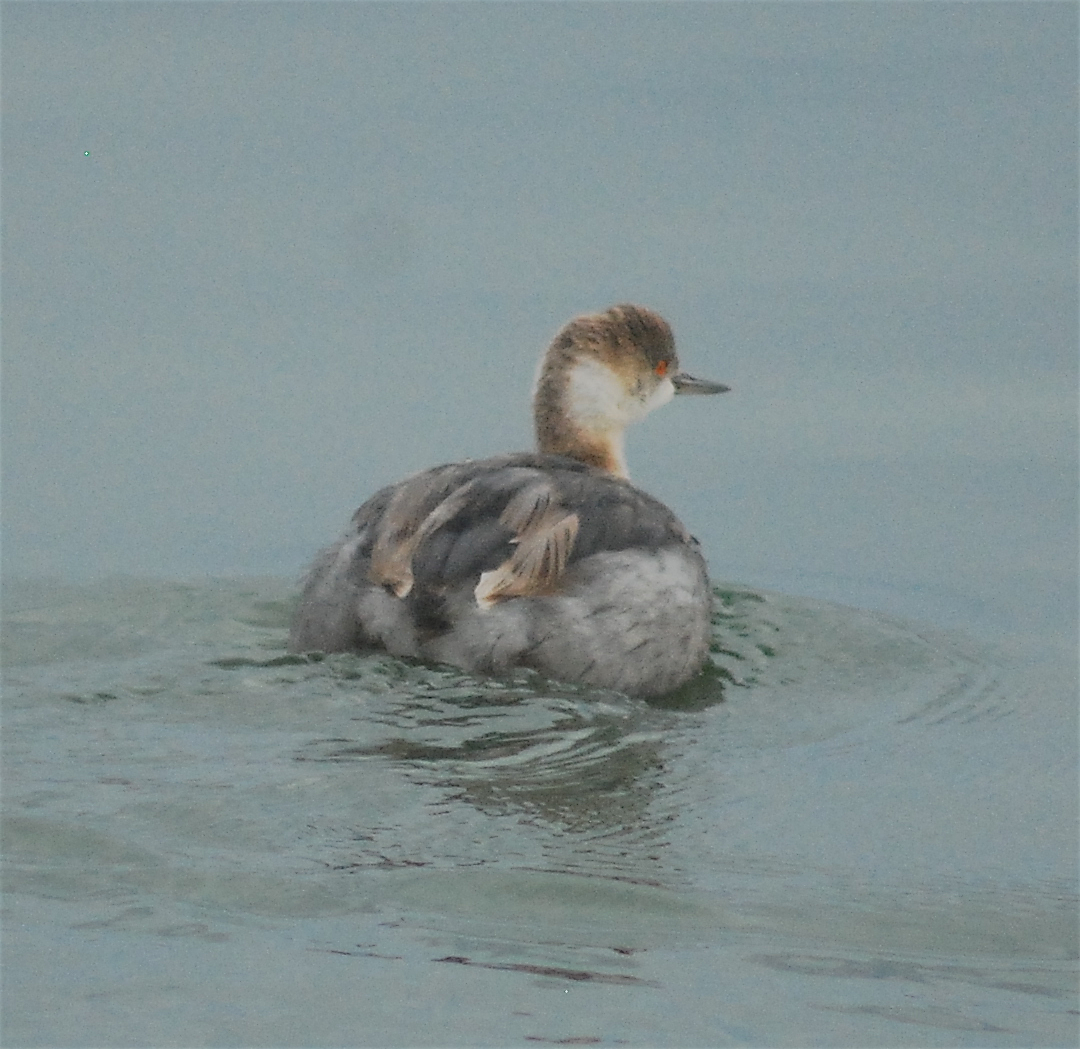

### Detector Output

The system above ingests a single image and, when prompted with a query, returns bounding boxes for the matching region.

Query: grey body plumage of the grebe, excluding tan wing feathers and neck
[289,453,711,696]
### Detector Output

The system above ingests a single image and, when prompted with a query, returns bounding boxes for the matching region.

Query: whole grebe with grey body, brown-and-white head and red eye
[289,306,728,696]
